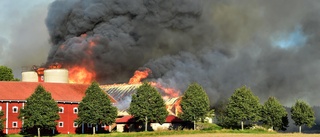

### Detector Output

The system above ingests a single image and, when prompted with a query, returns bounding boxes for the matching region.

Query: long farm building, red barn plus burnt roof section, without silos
[0,81,185,134]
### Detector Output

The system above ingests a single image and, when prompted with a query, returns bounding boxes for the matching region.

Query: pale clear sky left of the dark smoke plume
[0,0,53,78]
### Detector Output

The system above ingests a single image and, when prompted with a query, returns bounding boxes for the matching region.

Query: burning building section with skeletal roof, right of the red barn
[100,84,183,132]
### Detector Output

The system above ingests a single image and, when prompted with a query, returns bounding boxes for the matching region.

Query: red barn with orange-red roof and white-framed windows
[0,81,115,134]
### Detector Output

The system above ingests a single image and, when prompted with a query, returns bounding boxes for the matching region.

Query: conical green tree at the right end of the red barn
[75,82,117,134]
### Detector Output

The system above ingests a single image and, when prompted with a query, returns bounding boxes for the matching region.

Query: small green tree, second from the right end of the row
[261,97,289,130]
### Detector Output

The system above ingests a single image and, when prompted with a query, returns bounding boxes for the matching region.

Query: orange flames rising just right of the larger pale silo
[68,66,96,84]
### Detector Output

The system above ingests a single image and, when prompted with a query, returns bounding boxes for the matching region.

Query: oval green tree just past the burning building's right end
[179,83,210,128]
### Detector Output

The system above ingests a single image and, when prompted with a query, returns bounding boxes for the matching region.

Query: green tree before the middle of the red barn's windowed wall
[18,85,60,135]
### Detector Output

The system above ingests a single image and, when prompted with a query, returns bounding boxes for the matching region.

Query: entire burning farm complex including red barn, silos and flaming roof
[0,66,181,134]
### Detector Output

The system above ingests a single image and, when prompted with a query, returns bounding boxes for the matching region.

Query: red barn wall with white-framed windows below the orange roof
[0,101,107,134]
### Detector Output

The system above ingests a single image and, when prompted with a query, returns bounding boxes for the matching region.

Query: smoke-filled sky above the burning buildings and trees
[0,0,320,106]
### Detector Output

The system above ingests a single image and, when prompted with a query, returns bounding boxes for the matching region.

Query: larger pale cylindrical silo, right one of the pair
[44,69,69,83]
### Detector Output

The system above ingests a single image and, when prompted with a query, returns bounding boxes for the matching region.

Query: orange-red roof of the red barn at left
[0,81,116,103]
